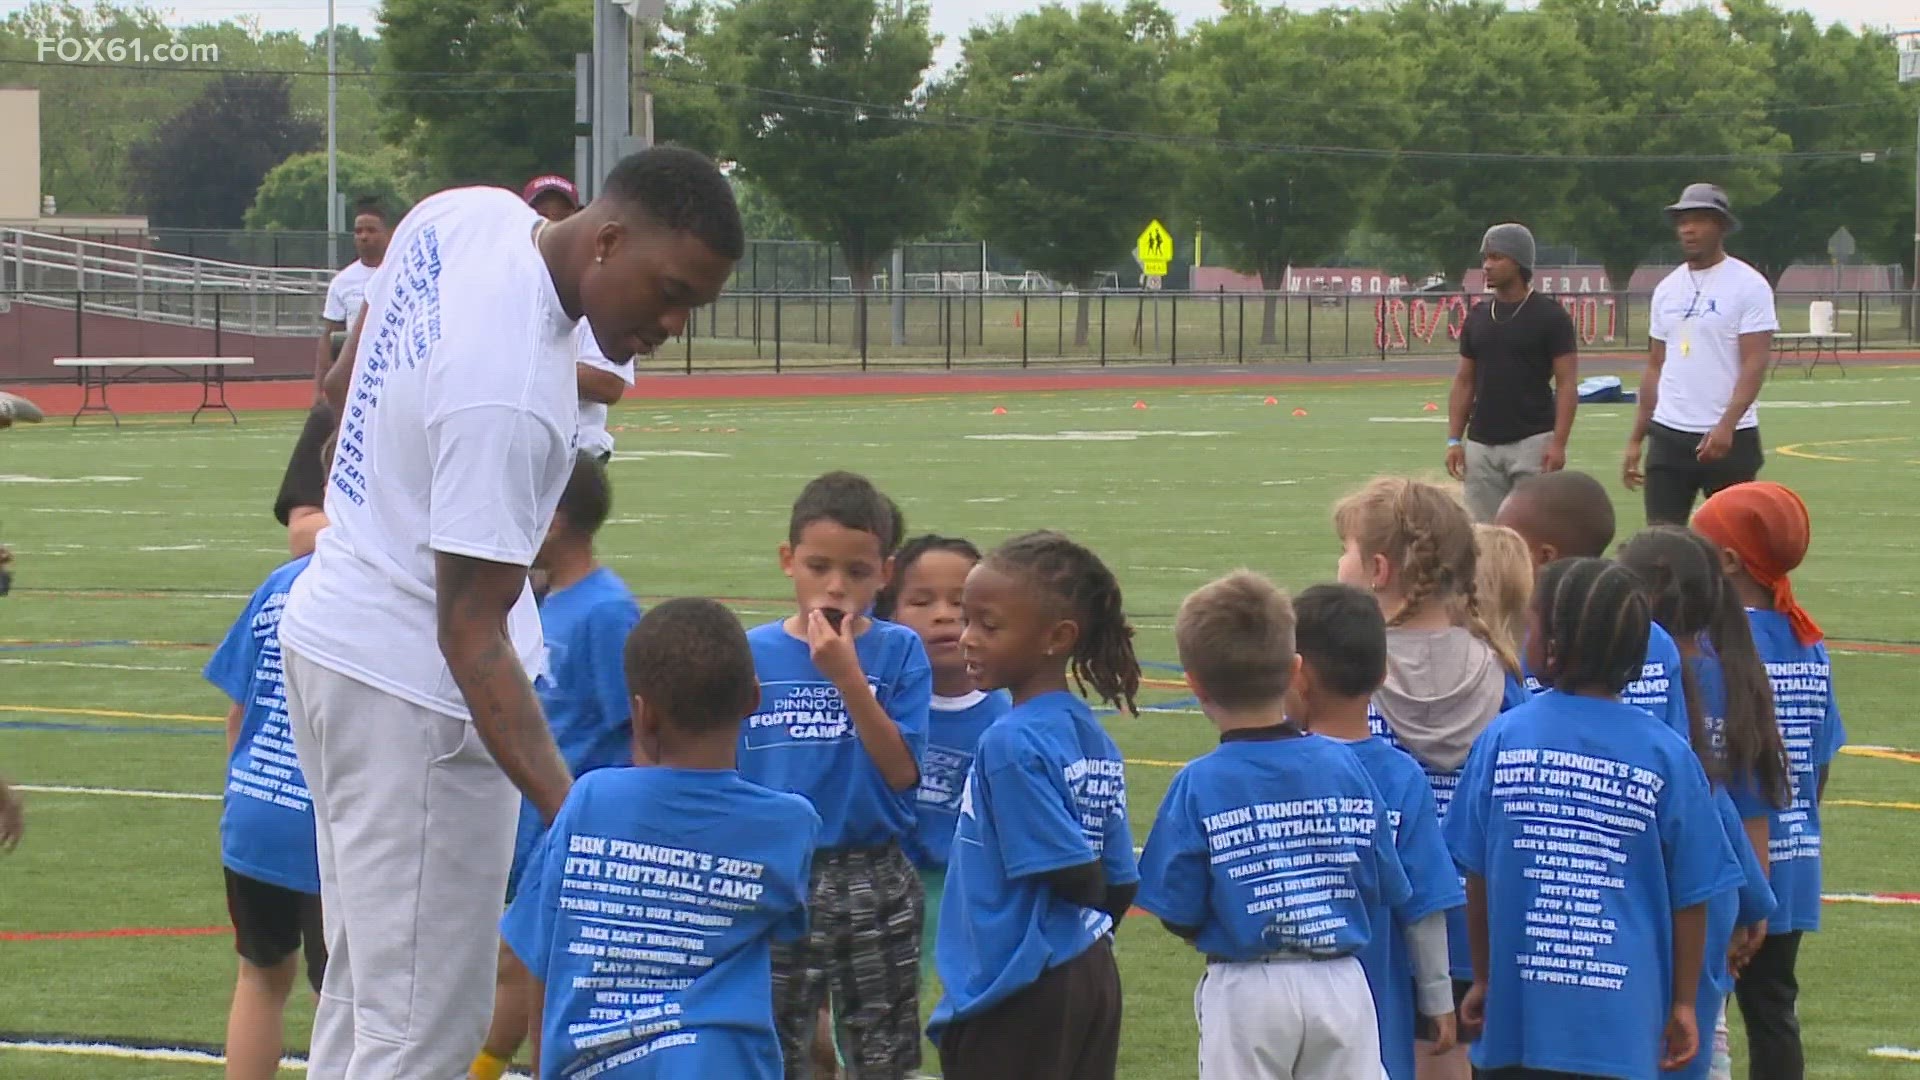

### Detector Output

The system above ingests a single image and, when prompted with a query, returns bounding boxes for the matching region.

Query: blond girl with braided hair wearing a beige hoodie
[1332,477,1528,1080]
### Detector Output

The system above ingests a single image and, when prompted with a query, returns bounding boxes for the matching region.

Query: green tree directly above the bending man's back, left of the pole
[380,0,593,188]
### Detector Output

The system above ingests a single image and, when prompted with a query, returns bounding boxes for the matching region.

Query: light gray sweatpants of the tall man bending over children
[284,650,520,1080]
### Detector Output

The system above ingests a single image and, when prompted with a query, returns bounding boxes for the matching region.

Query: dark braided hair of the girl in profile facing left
[987,530,1140,715]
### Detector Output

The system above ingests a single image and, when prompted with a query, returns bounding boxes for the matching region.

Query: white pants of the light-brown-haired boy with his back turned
[1194,957,1386,1080]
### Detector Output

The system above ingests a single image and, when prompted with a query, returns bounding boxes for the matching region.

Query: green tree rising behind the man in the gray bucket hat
[1540,0,1791,288]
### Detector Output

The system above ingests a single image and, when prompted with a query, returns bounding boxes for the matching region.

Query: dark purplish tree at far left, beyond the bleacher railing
[129,75,321,229]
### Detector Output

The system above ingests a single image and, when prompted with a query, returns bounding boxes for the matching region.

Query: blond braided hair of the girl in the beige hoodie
[1332,477,1521,678]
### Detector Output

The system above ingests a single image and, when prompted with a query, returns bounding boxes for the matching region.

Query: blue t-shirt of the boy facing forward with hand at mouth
[739,619,933,847]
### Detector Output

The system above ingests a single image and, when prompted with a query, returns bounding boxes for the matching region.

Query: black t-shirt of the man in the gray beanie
[1459,292,1576,446]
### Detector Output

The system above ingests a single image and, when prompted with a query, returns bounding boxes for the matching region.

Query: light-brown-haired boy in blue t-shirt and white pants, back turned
[1140,571,1428,1080]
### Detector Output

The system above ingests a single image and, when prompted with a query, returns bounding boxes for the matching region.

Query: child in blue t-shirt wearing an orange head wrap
[1693,480,1847,1080]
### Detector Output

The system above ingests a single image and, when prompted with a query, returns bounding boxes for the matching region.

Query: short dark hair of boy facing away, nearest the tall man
[626,598,760,730]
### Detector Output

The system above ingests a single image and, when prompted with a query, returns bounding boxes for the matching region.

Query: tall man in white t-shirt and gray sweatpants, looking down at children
[280,148,745,1080]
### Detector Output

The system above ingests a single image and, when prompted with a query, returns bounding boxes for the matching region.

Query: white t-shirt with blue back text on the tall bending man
[280,188,578,719]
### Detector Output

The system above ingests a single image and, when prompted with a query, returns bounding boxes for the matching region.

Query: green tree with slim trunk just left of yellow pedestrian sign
[954,0,1175,346]
